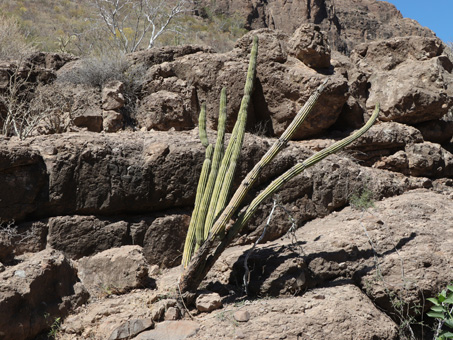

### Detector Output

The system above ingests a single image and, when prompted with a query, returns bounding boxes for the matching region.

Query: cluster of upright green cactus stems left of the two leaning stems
[182,37,258,267]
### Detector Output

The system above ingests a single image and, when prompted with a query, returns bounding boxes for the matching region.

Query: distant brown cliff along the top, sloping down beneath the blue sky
[199,0,435,54]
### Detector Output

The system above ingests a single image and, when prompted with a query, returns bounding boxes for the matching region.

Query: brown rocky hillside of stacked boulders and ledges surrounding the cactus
[0,0,453,340]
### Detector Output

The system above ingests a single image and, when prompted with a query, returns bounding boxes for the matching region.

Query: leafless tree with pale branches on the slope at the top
[92,0,192,52]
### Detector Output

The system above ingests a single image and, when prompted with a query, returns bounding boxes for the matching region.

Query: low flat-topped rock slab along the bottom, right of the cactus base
[196,284,398,340]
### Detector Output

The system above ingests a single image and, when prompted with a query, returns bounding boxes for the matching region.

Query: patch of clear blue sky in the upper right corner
[380,0,453,42]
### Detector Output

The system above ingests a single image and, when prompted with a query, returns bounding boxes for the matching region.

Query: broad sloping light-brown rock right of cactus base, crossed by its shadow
[204,189,453,314]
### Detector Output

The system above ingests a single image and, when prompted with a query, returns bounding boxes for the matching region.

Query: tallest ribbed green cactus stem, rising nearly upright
[205,36,258,233]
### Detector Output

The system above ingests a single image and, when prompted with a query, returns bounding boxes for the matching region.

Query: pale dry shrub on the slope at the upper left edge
[0,15,36,60]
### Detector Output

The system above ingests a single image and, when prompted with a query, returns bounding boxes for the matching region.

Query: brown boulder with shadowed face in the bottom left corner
[0,249,88,340]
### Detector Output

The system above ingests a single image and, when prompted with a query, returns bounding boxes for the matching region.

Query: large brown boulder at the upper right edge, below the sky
[351,37,453,124]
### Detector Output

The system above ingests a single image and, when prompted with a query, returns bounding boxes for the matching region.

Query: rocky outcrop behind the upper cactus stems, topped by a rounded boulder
[136,26,347,139]
